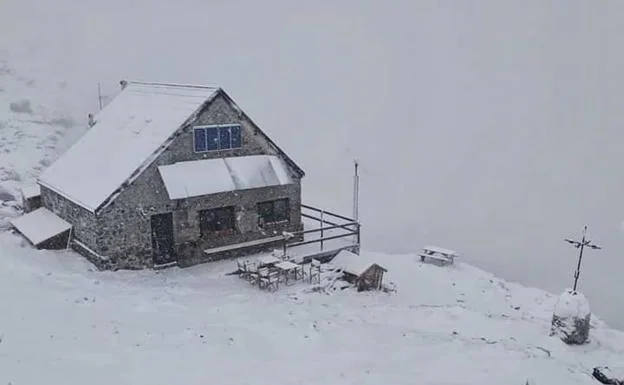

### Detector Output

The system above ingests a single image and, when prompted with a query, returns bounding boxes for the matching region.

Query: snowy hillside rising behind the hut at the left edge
[0,57,84,229]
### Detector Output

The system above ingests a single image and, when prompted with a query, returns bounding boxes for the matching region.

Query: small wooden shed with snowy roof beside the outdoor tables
[331,250,388,291]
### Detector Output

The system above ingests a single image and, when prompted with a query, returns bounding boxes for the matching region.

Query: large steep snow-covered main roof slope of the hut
[39,83,219,212]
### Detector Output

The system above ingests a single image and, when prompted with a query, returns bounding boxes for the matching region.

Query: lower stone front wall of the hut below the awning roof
[97,166,302,268]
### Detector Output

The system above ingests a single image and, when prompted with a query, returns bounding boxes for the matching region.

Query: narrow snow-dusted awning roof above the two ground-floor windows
[158,155,292,199]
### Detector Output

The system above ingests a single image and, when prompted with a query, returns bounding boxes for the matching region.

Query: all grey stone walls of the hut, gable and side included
[42,95,302,269]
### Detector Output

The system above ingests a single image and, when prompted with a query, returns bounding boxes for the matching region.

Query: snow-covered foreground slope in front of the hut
[0,233,624,385]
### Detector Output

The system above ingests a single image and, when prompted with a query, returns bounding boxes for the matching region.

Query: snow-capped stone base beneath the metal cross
[551,289,591,345]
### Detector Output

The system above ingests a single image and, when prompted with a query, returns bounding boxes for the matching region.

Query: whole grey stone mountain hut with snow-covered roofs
[13,81,304,269]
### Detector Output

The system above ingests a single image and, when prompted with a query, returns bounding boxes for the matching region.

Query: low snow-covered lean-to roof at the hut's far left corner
[11,207,71,246]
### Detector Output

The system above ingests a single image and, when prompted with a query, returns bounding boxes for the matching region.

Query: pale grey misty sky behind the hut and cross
[0,0,624,328]
